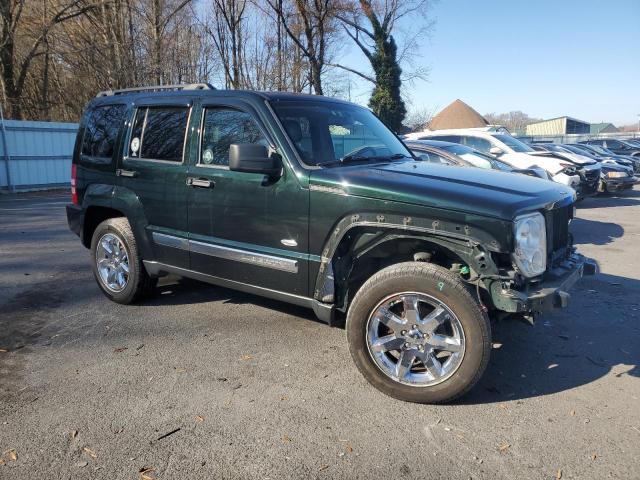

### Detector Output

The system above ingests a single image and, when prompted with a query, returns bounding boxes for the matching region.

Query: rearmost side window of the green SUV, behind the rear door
[82,105,126,159]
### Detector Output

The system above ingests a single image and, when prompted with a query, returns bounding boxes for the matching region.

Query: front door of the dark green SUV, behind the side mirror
[188,100,309,296]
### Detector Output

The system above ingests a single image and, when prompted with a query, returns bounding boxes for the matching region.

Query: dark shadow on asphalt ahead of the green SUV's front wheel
[459,274,640,404]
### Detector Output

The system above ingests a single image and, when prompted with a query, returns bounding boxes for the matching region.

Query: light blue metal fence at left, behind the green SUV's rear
[0,114,78,191]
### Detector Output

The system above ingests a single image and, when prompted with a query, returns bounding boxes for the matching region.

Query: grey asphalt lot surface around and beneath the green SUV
[0,190,640,480]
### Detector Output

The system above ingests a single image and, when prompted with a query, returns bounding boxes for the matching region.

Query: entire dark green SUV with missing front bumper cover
[67,84,595,403]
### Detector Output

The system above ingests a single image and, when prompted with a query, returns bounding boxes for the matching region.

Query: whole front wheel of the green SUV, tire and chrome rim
[347,262,491,403]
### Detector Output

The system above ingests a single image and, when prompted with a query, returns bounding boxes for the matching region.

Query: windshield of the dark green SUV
[271,101,411,165]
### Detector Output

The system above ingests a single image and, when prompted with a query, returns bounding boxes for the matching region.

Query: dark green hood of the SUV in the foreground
[310,161,575,220]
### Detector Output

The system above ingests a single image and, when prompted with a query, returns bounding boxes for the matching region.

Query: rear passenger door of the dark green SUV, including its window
[116,97,192,268]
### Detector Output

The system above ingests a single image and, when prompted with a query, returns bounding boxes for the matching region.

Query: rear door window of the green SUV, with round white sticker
[129,107,189,162]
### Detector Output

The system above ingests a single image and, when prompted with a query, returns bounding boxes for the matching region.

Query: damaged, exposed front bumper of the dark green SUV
[500,253,597,313]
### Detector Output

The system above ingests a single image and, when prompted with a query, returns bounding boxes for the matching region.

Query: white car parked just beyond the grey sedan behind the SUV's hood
[404,129,580,190]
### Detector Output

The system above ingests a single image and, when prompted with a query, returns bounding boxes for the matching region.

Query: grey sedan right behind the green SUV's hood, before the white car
[406,140,550,180]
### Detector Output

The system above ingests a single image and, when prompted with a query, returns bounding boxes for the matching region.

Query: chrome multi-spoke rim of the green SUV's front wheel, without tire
[366,292,465,387]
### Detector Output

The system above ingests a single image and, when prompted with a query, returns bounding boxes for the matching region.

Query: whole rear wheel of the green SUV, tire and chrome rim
[91,217,157,304]
